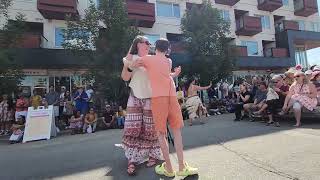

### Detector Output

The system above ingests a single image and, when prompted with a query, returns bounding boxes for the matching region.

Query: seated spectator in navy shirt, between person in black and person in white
[243,82,268,121]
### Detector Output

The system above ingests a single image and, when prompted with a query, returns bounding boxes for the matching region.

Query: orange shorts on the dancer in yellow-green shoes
[151,96,183,133]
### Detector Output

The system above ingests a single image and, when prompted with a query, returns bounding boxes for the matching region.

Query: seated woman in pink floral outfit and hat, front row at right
[280,71,317,127]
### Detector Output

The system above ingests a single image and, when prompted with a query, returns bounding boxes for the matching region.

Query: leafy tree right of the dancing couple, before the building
[181,0,232,83]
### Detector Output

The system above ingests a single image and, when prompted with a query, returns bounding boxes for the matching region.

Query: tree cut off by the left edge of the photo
[0,0,25,94]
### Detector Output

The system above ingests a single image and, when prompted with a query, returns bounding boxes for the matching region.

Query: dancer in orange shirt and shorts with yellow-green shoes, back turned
[133,39,198,177]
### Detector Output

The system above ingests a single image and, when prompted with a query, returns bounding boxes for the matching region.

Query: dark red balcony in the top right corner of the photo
[294,0,318,17]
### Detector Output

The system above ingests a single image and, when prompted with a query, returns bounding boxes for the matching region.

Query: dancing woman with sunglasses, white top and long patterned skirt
[121,36,162,175]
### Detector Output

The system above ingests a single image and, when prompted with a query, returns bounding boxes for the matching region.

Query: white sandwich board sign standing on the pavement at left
[22,106,57,143]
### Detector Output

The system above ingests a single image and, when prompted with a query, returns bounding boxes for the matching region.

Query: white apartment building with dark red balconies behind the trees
[0,0,320,93]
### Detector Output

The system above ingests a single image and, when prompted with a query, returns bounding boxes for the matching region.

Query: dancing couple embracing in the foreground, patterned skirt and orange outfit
[121,36,198,177]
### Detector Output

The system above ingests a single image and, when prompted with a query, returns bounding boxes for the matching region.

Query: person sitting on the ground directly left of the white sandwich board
[9,116,25,144]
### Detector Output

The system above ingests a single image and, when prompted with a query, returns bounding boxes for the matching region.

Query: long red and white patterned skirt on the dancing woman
[122,94,162,164]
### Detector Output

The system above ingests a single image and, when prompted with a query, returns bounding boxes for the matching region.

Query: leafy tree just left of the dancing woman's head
[63,0,139,103]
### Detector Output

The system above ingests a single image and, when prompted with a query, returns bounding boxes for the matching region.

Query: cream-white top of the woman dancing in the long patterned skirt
[123,55,152,99]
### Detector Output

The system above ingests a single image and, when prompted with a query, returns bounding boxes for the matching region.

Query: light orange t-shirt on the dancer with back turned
[141,55,177,97]
